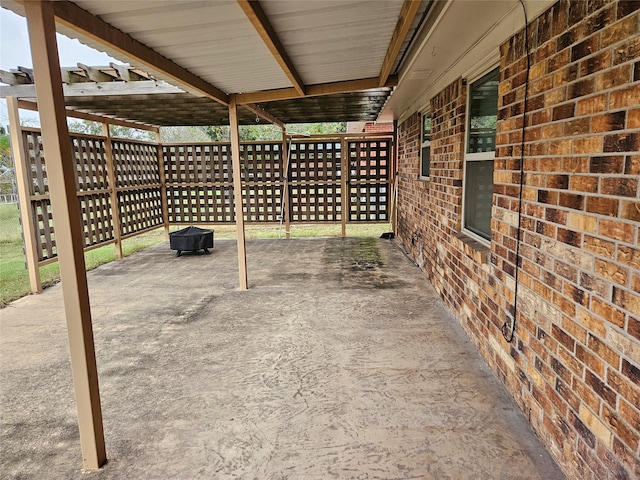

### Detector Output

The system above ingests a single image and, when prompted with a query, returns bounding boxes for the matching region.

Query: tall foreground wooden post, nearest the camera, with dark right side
[24,1,107,469]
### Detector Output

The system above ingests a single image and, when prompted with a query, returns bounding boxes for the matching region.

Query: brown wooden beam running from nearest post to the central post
[49,0,229,105]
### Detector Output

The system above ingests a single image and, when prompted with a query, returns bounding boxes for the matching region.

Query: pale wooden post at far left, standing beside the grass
[7,97,42,293]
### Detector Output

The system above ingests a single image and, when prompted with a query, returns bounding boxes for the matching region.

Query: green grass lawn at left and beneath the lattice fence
[0,205,390,308]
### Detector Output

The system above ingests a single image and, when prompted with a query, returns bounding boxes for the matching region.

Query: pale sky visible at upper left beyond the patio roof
[0,8,121,127]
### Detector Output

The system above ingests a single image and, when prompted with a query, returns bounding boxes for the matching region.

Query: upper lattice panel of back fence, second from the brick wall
[289,140,342,183]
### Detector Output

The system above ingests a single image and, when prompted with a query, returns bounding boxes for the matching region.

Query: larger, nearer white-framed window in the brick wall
[464,68,499,240]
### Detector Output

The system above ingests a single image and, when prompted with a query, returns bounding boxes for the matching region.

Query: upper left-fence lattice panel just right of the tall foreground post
[71,135,109,192]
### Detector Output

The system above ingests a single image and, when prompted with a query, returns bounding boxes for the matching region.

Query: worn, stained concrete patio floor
[0,238,564,480]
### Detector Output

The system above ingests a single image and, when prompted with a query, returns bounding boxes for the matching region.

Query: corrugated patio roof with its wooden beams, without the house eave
[2,0,432,125]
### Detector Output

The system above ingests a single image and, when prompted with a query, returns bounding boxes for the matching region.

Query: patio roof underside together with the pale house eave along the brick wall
[0,0,552,125]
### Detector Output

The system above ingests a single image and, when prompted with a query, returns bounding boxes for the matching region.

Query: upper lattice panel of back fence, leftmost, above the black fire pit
[163,143,233,184]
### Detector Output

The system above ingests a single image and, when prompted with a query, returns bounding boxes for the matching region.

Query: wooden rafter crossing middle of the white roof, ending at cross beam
[237,0,305,96]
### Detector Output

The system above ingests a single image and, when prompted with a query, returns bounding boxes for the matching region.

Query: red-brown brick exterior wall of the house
[396,0,640,480]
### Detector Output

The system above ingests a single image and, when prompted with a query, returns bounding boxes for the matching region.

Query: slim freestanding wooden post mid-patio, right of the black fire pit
[229,95,249,290]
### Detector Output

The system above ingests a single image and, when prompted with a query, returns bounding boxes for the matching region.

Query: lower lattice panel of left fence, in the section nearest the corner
[118,188,163,235]
